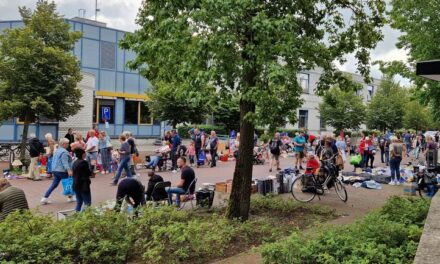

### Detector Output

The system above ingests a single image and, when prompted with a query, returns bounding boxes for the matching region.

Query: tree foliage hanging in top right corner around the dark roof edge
[379,0,440,121]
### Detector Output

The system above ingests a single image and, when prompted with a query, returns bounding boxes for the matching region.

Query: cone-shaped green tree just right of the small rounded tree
[366,76,408,131]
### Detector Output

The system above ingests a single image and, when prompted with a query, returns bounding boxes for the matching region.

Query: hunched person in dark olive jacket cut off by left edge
[0,179,29,222]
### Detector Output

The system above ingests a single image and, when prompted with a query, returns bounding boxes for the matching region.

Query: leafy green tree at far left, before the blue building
[0,1,81,159]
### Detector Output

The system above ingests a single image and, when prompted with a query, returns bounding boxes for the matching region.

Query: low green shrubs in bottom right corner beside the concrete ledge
[262,196,429,264]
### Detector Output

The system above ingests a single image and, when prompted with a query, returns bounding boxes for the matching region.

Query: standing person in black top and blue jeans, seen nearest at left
[72,148,92,212]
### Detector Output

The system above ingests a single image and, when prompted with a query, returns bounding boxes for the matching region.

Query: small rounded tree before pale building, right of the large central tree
[319,87,365,131]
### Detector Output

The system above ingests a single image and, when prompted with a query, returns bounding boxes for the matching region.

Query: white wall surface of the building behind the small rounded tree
[286,69,380,134]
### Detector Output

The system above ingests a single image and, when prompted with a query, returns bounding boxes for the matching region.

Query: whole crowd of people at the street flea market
[0,126,439,220]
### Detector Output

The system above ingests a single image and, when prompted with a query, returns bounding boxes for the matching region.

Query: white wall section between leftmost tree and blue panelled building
[58,72,95,138]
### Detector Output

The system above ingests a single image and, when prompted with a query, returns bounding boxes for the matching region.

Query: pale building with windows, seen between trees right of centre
[286,69,380,134]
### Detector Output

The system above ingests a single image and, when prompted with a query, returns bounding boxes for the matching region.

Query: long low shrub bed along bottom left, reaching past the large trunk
[0,196,333,263]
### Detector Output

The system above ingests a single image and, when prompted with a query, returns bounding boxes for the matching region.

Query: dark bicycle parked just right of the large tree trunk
[291,156,348,203]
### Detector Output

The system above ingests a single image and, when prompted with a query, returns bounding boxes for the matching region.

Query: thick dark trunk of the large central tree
[226,100,255,221]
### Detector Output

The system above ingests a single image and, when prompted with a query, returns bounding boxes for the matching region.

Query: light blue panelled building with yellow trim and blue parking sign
[0,18,161,142]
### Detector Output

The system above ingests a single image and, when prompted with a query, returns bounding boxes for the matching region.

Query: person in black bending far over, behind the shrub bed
[115,177,145,212]
